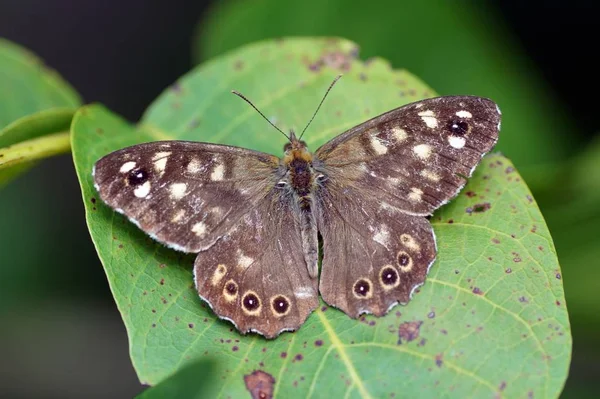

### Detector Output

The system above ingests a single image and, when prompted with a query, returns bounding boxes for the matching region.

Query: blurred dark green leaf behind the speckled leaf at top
[194,0,575,172]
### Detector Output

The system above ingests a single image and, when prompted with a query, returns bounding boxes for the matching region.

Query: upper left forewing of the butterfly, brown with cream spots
[94,141,279,252]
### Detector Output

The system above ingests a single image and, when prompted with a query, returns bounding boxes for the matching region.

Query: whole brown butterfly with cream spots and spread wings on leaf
[93,79,500,338]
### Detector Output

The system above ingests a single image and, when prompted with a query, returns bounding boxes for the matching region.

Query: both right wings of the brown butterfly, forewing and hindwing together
[316,97,500,317]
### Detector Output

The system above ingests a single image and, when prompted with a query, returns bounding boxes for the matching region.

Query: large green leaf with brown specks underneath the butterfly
[72,39,571,398]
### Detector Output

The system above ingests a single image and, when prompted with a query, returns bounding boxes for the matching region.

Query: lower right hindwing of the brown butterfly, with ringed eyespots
[318,183,436,317]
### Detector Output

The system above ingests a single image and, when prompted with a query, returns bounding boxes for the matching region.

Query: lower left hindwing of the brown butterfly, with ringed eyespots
[194,191,319,338]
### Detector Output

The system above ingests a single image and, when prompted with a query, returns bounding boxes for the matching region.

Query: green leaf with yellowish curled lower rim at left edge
[0,38,81,186]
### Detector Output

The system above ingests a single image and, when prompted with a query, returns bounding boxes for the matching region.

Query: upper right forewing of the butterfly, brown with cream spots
[316,97,500,215]
